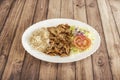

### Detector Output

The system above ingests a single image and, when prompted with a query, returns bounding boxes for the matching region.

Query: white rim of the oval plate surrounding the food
[22,18,101,63]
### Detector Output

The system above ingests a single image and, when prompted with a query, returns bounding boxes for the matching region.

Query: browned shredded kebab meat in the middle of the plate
[44,24,72,56]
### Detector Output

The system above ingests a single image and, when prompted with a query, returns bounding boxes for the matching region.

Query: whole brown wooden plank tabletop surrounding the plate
[0,0,120,80]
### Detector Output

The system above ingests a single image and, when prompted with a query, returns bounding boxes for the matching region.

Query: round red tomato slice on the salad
[74,35,91,50]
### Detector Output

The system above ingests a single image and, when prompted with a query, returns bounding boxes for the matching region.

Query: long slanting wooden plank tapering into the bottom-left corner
[0,0,24,79]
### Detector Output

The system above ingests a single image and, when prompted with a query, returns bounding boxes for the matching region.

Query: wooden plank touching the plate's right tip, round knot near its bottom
[86,0,112,80]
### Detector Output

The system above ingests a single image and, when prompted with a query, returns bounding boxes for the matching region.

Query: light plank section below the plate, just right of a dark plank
[39,61,57,80]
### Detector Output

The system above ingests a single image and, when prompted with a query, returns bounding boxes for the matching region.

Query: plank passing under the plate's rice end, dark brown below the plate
[21,0,48,80]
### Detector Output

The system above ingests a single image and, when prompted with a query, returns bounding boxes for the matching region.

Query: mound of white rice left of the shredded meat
[29,28,49,52]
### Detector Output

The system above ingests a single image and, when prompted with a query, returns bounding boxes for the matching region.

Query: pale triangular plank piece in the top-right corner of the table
[108,0,120,37]
